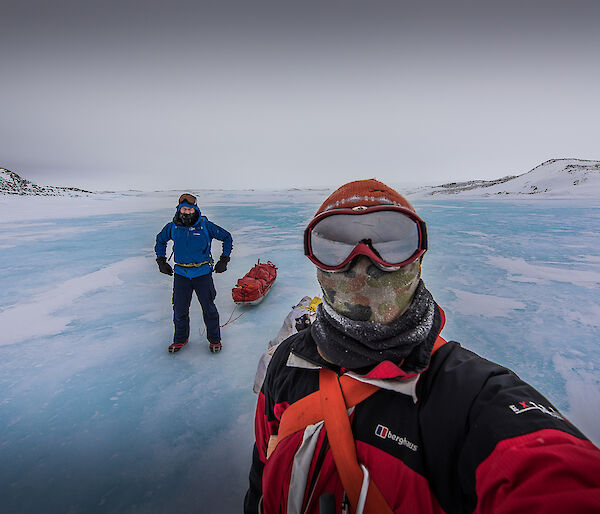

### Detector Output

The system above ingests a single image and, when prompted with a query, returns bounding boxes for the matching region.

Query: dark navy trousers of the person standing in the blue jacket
[173,273,221,343]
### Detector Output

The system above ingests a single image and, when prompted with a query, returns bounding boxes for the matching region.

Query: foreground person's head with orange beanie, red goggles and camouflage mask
[304,181,427,323]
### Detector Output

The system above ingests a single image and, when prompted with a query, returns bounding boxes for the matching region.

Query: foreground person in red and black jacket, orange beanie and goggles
[245,179,600,514]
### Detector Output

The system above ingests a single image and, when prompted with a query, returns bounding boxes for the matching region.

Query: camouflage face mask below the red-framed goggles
[317,256,421,323]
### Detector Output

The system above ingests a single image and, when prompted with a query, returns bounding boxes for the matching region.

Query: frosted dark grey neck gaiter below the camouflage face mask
[311,280,442,373]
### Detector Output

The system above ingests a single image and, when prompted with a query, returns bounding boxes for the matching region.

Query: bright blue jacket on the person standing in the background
[154,204,233,278]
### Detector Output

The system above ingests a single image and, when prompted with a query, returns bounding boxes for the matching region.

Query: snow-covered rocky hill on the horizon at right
[417,159,600,199]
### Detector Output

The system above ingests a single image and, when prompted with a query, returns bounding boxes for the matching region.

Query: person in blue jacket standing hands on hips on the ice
[154,193,233,353]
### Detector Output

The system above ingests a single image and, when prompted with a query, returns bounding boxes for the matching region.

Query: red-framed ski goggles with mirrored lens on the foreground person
[304,205,427,271]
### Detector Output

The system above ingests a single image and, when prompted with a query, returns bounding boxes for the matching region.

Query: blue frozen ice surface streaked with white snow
[0,191,600,514]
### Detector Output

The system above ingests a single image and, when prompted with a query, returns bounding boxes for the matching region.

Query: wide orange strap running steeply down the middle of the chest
[319,369,393,514]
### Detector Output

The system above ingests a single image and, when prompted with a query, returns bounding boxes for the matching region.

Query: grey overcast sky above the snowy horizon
[0,0,600,189]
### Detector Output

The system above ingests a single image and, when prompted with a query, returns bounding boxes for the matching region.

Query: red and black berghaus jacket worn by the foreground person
[245,330,600,513]
